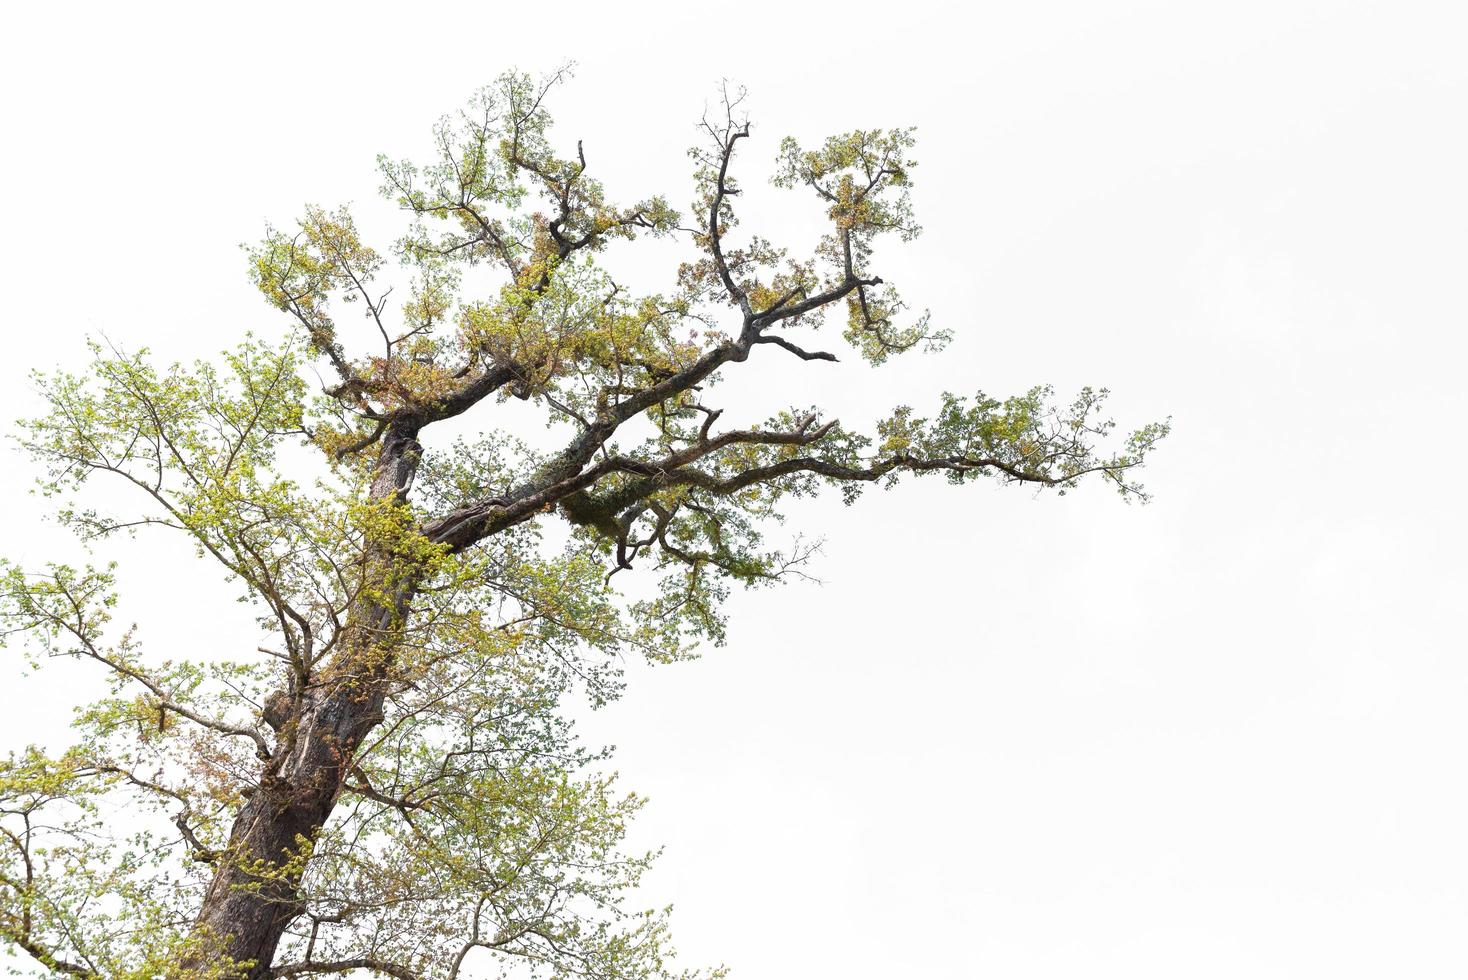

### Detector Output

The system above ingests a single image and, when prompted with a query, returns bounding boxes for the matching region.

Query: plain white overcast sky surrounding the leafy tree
[0,0,1468,980]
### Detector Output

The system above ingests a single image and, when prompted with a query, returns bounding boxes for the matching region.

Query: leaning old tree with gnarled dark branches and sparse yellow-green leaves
[0,72,1167,980]
